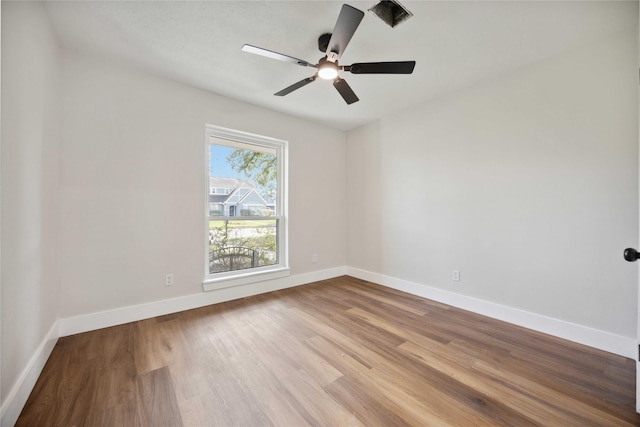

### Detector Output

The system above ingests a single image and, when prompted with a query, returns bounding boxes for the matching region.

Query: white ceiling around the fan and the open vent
[46,0,638,130]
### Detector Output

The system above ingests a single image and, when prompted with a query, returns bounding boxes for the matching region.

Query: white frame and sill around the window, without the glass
[202,124,290,291]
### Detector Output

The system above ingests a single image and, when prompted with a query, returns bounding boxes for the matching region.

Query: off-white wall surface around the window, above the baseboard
[59,48,346,318]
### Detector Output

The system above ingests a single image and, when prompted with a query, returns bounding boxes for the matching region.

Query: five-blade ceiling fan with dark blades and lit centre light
[242,4,416,104]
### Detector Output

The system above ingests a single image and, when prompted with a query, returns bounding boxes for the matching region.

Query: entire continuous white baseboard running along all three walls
[5,266,638,427]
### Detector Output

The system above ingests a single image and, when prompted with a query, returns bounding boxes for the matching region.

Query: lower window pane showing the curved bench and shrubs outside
[209,219,278,274]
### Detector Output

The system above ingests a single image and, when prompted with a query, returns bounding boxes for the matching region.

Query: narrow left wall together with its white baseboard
[0,2,59,425]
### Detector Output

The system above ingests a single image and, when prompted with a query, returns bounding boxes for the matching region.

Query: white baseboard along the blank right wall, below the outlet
[347,267,638,360]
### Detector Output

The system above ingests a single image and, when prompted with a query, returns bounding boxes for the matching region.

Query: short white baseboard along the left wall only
[0,321,59,427]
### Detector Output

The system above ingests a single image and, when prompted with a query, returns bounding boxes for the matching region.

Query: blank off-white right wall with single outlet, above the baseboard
[347,28,638,342]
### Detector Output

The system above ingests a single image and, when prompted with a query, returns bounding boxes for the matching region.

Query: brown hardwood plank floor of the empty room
[17,277,640,427]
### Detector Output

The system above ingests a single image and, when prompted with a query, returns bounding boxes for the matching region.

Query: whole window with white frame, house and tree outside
[204,125,289,290]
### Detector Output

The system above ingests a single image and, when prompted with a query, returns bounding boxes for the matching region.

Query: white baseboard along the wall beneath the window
[60,267,347,336]
